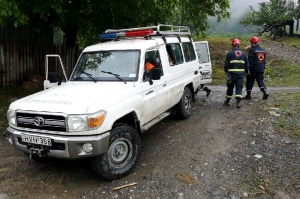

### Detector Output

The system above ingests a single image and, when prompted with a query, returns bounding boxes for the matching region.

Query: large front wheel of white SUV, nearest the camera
[92,124,142,180]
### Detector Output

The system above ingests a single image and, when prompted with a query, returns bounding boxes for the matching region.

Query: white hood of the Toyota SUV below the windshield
[10,82,132,114]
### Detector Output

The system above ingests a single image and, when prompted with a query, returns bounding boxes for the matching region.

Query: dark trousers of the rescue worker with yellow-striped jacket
[226,73,244,99]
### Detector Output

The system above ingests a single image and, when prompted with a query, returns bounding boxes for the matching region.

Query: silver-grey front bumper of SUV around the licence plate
[6,127,110,159]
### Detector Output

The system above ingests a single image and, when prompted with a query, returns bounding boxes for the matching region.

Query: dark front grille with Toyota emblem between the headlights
[17,112,66,132]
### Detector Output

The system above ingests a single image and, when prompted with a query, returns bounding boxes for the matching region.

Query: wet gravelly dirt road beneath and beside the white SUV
[0,86,300,199]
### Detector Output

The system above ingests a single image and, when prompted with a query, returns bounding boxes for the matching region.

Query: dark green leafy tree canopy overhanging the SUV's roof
[0,0,230,46]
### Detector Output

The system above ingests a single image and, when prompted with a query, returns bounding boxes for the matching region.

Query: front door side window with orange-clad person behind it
[143,50,163,82]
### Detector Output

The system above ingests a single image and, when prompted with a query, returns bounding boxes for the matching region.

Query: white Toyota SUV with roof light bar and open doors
[7,25,211,180]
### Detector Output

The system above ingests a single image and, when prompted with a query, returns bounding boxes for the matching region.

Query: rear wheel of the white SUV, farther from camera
[176,87,193,119]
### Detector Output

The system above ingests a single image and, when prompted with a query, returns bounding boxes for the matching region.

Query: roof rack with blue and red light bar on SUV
[98,24,191,39]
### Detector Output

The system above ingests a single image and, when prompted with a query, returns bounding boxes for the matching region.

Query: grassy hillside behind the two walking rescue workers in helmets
[205,37,300,87]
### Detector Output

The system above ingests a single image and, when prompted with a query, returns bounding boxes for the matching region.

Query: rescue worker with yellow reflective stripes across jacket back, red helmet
[224,39,249,108]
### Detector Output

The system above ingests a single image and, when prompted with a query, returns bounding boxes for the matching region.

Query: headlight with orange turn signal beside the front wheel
[68,111,106,132]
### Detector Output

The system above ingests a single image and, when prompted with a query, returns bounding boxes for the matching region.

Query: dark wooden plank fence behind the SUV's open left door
[0,41,81,87]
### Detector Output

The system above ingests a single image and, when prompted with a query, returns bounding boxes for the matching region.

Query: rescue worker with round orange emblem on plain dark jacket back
[243,37,269,100]
